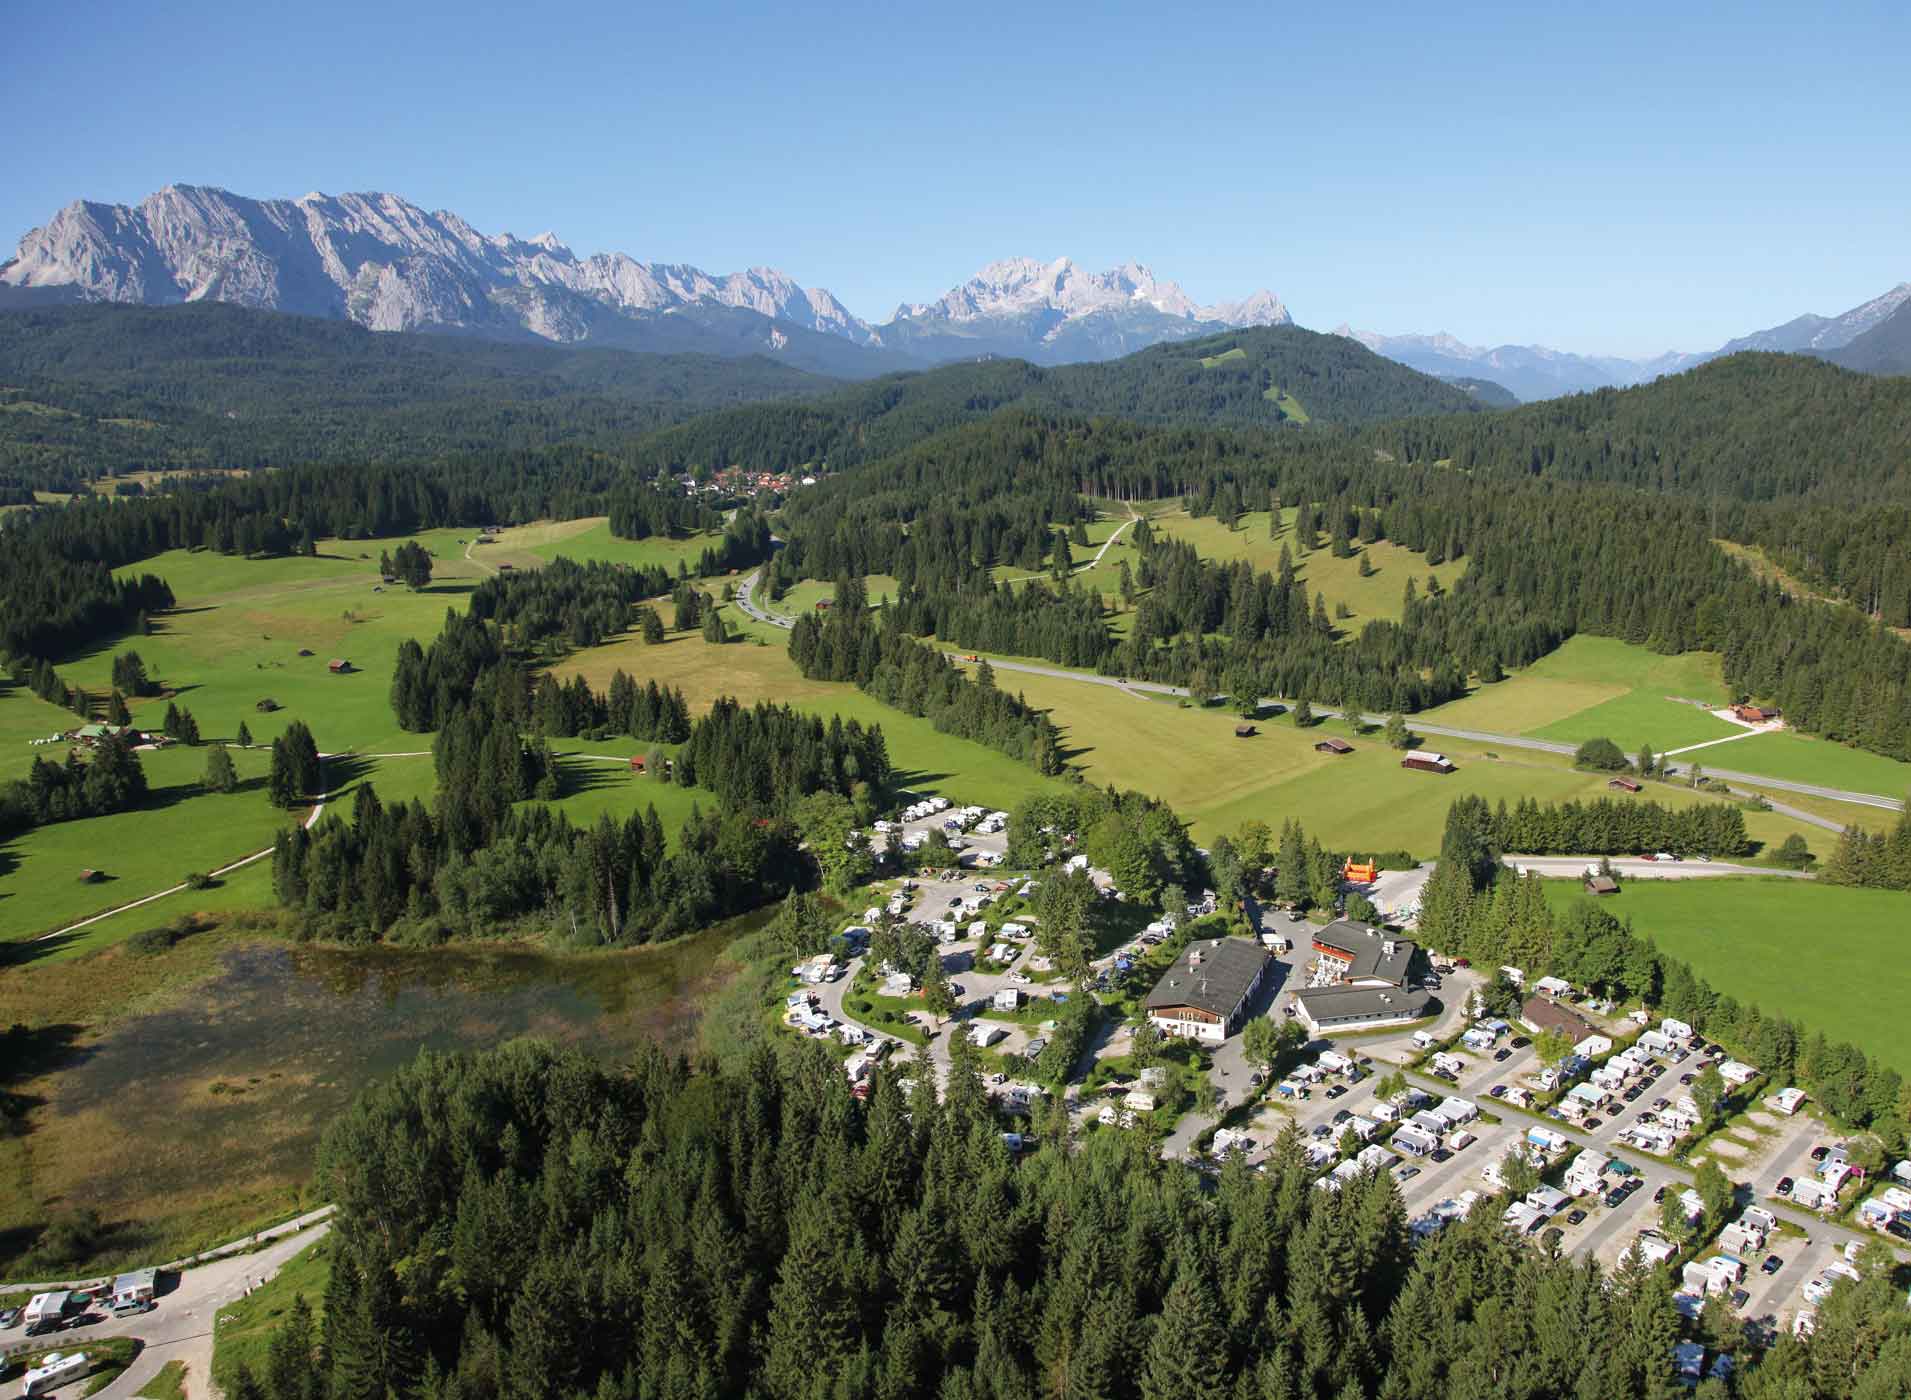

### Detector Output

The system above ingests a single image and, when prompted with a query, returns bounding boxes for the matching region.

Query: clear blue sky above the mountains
[0,0,1911,353]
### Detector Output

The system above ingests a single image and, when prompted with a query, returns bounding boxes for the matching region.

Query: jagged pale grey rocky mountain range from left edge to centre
[0,185,1290,376]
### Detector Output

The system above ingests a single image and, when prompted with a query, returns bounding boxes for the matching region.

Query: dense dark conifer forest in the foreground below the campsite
[219,1037,1911,1400]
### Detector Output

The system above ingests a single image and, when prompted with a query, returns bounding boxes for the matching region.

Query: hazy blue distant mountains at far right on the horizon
[1336,283,1911,399]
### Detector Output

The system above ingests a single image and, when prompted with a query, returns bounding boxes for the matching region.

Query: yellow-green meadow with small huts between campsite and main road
[996,670,1835,858]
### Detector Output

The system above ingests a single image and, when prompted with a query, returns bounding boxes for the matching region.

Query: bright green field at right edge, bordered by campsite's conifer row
[1546,879,1911,1073]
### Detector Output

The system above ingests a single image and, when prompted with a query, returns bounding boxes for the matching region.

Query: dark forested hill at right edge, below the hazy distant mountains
[1372,353,1911,502]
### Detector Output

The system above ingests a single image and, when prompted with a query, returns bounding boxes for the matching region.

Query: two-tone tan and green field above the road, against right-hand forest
[1422,636,1733,749]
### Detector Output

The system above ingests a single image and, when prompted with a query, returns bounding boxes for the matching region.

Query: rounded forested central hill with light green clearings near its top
[619,327,1487,470]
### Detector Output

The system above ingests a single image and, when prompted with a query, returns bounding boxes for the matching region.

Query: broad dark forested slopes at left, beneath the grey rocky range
[0,302,837,489]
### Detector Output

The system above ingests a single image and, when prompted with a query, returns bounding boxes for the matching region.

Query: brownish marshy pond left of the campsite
[42,928,736,1217]
